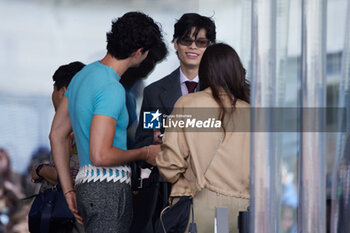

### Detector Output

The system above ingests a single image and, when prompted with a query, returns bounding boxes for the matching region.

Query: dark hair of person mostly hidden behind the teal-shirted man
[52,61,85,91]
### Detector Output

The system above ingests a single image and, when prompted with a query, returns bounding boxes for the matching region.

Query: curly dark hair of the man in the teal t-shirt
[107,12,162,59]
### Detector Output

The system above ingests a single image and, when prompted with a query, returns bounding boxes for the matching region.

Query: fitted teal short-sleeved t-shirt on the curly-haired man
[65,61,129,167]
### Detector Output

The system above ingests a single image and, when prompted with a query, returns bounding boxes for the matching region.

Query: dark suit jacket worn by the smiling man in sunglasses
[135,68,182,148]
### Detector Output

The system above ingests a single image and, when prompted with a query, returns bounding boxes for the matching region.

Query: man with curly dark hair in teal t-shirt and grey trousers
[50,12,162,233]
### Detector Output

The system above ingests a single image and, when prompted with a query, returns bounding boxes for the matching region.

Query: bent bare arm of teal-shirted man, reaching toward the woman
[89,115,160,166]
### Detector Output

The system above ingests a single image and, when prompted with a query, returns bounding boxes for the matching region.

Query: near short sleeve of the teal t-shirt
[93,82,125,120]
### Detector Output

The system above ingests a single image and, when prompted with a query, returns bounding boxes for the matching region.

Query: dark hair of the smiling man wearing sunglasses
[173,13,216,43]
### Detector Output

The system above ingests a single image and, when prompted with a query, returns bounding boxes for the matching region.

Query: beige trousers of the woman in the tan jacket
[186,189,249,233]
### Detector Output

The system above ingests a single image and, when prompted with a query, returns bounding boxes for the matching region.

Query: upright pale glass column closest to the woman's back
[250,0,279,233]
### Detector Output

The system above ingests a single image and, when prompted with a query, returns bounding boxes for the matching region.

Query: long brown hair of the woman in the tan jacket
[198,43,250,131]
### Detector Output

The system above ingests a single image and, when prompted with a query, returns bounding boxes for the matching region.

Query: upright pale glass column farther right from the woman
[298,0,327,233]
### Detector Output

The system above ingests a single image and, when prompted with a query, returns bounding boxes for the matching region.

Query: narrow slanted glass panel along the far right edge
[331,2,350,233]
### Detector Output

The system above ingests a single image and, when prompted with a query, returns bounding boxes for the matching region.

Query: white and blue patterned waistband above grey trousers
[75,165,131,185]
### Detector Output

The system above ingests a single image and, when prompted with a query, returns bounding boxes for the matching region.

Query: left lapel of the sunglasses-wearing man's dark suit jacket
[159,68,182,114]
